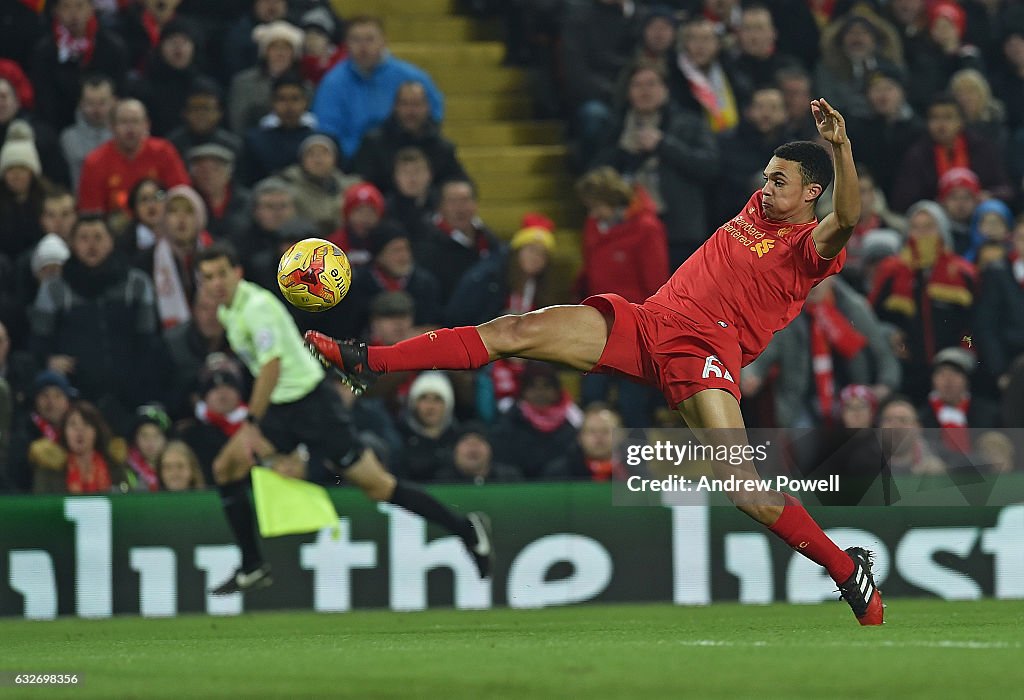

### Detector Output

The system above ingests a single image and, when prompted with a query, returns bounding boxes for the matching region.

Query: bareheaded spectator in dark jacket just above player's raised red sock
[410,178,503,301]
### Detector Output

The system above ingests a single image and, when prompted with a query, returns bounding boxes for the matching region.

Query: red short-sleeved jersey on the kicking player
[648,189,846,366]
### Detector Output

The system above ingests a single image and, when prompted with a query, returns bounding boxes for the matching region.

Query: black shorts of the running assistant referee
[259,380,365,483]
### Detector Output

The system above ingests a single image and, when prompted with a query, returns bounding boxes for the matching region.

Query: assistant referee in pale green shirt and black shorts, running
[197,243,493,595]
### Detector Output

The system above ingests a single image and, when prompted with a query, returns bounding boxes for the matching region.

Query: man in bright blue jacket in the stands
[313,16,444,159]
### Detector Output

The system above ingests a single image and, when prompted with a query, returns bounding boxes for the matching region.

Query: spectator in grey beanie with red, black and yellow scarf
[870,201,976,401]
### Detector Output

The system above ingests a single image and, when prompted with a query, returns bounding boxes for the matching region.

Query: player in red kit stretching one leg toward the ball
[306,99,883,624]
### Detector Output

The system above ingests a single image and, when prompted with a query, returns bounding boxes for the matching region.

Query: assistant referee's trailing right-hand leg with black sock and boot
[343,449,495,578]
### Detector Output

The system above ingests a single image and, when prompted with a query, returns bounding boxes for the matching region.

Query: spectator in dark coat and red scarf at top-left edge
[30,0,129,130]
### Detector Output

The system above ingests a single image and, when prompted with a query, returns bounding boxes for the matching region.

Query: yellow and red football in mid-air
[278,238,352,311]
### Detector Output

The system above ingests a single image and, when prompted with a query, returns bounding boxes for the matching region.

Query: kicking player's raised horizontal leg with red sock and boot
[305,305,608,393]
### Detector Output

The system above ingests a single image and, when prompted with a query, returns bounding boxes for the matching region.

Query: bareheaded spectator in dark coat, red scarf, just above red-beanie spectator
[890,94,1012,212]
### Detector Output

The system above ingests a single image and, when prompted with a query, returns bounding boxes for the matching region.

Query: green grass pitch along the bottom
[0,600,1024,700]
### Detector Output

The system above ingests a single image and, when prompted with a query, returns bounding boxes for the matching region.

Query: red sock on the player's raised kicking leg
[367,325,490,371]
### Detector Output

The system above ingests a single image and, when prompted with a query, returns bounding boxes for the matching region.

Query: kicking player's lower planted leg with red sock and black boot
[679,389,883,625]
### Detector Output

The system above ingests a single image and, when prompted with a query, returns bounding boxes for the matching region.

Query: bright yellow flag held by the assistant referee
[252,467,338,537]
